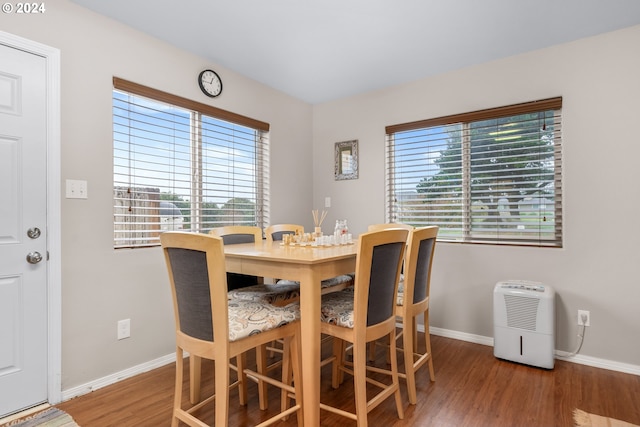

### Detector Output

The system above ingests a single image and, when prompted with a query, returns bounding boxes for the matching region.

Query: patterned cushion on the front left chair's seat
[229,300,300,341]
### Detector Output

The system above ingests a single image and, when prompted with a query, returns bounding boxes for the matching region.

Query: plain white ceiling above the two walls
[72,0,640,104]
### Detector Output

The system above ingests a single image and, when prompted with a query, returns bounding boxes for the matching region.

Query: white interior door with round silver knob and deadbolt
[0,44,48,417]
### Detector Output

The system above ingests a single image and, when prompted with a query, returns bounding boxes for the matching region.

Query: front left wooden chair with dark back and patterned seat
[160,232,301,427]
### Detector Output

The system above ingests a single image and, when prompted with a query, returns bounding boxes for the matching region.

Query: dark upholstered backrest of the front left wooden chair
[160,232,229,344]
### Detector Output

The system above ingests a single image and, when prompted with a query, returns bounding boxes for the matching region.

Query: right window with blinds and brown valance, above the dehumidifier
[386,98,562,247]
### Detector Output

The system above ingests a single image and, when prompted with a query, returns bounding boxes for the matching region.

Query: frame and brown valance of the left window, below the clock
[112,76,270,249]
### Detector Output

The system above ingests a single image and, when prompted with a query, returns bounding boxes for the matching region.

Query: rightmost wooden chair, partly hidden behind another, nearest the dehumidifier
[396,226,438,405]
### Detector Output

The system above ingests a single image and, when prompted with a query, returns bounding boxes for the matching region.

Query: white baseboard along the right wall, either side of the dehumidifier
[418,324,640,375]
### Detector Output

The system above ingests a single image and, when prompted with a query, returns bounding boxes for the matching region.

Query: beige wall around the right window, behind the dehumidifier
[313,27,640,369]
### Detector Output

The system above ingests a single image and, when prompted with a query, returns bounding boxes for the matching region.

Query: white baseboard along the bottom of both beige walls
[62,324,640,402]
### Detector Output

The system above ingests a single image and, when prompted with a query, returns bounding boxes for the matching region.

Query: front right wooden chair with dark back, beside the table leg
[320,229,409,427]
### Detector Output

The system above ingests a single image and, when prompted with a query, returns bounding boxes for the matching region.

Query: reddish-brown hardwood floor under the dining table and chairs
[57,336,640,427]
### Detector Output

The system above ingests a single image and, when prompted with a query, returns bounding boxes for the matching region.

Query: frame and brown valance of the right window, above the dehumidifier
[385,97,563,248]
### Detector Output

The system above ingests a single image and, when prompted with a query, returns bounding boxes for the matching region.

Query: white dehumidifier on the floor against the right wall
[493,280,555,369]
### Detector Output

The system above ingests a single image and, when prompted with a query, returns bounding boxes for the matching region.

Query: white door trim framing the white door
[0,31,62,404]
